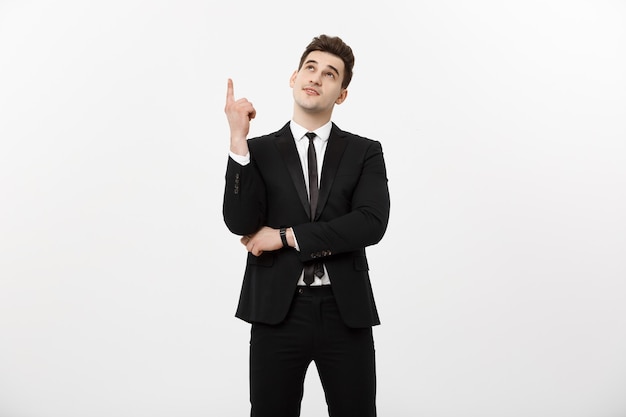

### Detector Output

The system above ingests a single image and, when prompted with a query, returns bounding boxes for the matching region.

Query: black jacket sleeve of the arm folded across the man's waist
[293,141,390,261]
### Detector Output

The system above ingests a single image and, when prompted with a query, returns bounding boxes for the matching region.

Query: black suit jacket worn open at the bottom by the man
[223,123,390,327]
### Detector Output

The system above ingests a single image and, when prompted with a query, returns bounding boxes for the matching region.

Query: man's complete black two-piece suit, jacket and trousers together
[224,123,390,417]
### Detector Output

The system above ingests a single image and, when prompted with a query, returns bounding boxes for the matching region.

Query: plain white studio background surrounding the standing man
[0,0,626,417]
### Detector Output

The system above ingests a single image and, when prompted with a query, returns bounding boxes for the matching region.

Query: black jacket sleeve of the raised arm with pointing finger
[222,157,266,236]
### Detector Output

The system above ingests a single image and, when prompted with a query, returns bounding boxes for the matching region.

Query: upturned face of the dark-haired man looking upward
[289,51,348,114]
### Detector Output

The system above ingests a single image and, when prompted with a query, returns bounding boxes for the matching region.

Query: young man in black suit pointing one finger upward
[223,35,390,417]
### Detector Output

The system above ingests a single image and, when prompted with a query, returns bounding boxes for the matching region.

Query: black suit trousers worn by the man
[250,287,376,417]
